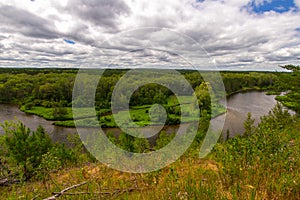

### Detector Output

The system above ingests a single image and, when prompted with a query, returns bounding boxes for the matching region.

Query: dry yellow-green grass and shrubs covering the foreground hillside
[0,105,300,199]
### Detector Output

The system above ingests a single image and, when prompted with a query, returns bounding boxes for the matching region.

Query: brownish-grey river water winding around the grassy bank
[0,91,282,142]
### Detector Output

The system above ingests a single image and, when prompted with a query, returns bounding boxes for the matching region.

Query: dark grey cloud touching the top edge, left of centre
[66,0,130,29]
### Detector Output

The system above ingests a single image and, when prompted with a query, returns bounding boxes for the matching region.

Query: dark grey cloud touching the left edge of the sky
[0,5,58,39]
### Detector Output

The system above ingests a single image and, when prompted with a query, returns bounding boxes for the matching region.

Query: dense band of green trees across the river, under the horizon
[0,69,277,108]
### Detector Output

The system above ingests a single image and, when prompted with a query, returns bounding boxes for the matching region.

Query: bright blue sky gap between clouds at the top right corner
[250,0,296,14]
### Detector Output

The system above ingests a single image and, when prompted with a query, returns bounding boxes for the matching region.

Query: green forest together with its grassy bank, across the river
[0,69,283,127]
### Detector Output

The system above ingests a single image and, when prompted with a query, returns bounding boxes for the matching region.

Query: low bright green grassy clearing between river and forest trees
[44,96,226,127]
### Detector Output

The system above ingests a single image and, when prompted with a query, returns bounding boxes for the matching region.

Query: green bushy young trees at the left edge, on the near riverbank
[0,121,83,180]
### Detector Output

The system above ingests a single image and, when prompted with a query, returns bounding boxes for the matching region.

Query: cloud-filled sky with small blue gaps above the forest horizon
[0,0,300,71]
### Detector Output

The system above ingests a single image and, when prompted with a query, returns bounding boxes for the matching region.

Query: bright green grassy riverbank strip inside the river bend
[20,97,226,128]
